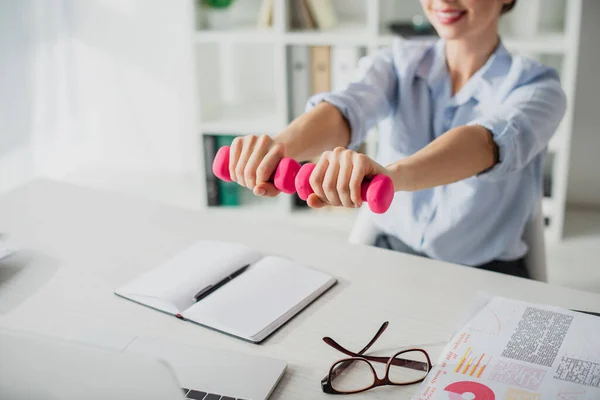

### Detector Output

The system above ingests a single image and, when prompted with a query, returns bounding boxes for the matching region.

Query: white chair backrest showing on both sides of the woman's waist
[348,199,548,282]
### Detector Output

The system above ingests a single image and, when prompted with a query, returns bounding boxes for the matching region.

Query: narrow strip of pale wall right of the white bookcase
[567,0,600,207]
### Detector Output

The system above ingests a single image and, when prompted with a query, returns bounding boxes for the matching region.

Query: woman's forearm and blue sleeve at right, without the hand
[386,70,566,191]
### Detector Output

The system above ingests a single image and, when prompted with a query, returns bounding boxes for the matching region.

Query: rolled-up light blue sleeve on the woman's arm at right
[467,69,567,180]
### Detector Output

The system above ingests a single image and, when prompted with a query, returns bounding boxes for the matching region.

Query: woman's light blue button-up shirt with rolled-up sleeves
[307,39,566,266]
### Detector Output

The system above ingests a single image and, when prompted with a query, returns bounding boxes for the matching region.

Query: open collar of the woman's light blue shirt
[417,39,510,106]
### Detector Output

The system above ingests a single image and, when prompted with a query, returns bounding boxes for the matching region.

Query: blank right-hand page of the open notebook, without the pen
[183,256,334,338]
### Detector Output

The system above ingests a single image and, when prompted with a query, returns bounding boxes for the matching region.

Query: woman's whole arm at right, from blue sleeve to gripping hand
[308,69,566,207]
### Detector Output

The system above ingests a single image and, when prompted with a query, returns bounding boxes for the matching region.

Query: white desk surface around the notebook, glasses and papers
[0,180,600,399]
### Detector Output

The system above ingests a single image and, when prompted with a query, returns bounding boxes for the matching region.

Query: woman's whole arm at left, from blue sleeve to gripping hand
[229,50,398,196]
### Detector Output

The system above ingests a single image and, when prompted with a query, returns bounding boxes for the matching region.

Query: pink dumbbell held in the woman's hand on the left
[213,146,300,194]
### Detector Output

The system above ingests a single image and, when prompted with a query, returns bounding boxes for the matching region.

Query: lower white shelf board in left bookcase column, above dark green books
[200,102,284,135]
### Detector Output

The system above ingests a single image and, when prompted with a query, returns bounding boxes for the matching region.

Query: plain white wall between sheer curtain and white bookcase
[70,0,198,172]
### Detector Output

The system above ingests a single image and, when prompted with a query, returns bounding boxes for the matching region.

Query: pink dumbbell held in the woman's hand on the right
[296,163,394,214]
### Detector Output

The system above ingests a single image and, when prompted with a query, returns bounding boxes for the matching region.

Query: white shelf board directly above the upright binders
[284,21,369,46]
